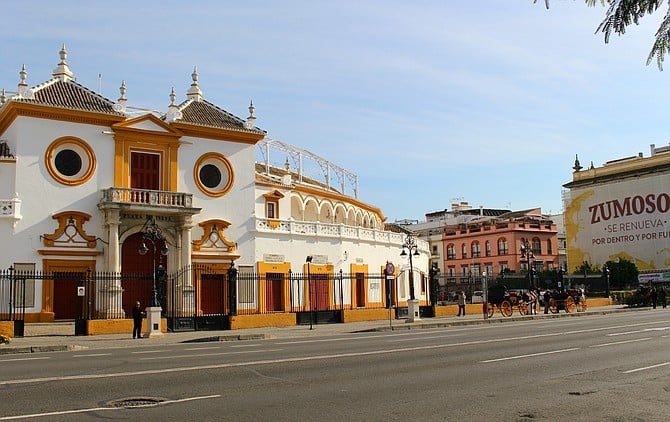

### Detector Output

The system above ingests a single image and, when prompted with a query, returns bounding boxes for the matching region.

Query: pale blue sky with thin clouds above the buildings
[0,0,670,222]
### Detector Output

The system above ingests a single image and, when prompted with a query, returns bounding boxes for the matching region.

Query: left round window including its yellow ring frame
[44,137,96,186]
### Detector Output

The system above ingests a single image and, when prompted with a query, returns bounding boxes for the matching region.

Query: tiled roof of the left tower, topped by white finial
[12,79,124,116]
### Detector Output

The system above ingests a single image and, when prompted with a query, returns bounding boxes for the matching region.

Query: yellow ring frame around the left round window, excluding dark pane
[44,136,97,186]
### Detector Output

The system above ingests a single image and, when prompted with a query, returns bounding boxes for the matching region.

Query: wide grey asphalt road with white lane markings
[0,310,670,421]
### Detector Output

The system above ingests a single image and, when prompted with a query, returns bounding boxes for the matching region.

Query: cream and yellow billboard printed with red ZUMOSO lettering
[564,174,670,271]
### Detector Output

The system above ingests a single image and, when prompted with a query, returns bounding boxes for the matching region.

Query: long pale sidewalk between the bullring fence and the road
[0,305,650,355]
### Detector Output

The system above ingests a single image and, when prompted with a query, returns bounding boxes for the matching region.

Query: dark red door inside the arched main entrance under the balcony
[121,233,167,317]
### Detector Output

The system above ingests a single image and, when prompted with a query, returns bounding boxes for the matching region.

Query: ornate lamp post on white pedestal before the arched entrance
[137,216,169,336]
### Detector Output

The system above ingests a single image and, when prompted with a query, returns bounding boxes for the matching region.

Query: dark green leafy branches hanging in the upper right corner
[533,0,670,70]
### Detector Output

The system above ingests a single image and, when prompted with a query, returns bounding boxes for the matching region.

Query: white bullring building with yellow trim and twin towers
[0,47,428,322]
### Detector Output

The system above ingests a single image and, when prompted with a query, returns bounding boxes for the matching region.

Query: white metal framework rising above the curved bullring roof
[257,138,358,199]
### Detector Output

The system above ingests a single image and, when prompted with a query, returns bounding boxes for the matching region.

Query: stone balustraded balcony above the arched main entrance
[99,188,200,214]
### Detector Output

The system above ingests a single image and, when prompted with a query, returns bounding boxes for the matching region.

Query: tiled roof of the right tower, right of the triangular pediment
[178,99,265,134]
